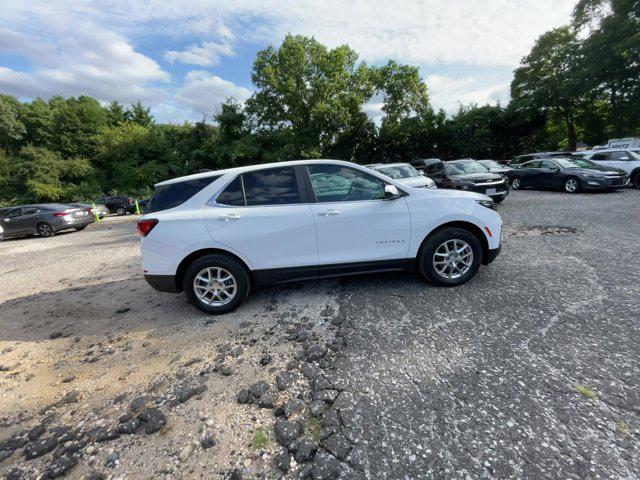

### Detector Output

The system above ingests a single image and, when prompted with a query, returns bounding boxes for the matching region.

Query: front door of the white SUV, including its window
[307,163,411,264]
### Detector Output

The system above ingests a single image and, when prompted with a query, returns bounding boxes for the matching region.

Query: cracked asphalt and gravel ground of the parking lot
[0,189,640,479]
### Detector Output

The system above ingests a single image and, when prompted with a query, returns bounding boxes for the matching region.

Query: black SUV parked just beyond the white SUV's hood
[411,158,509,203]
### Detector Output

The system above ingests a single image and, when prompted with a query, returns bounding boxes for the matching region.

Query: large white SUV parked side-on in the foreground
[138,160,502,313]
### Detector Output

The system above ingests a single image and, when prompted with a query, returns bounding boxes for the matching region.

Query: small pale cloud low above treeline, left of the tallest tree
[174,70,251,115]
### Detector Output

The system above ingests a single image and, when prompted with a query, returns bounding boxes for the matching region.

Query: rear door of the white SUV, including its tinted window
[203,166,318,281]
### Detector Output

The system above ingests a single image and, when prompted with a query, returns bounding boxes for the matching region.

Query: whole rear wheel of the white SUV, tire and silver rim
[183,253,251,314]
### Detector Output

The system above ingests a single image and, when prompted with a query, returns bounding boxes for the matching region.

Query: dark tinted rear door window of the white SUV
[242,167,301,207]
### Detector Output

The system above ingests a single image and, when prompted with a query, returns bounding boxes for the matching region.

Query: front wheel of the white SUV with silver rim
[418,227,482,287]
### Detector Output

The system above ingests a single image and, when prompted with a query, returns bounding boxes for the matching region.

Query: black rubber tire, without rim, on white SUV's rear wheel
[182,253,251,315]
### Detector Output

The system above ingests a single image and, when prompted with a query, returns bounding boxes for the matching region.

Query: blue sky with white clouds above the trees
[0,0,575,122]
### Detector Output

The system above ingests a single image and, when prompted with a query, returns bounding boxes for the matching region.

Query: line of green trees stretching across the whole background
[0,0,640,204]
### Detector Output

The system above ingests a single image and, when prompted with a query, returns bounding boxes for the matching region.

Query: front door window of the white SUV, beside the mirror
[307,165,385,203]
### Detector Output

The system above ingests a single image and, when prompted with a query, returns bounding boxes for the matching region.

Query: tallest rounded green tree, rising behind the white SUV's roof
[247,35,374,160]
